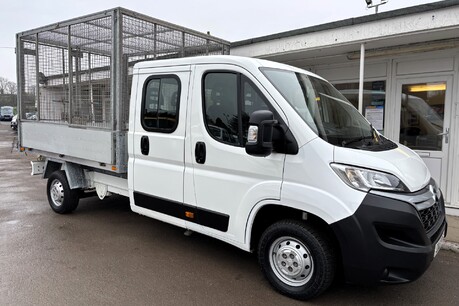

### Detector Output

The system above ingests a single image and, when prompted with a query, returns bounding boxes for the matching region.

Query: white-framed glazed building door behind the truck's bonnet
[396,76,452,194]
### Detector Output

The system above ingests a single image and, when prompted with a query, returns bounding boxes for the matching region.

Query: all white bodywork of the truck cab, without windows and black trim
[123,56,430,250]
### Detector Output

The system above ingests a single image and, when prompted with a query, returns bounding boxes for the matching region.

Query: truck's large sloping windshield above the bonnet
[262,68,392,148]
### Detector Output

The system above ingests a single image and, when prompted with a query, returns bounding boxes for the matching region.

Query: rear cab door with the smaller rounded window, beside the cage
[128,66,190,227]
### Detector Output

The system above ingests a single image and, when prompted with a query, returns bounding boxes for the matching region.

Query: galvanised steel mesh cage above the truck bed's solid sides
[17,8,229,131]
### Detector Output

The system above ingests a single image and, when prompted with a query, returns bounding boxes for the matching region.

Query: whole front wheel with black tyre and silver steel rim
[258,220,337,300]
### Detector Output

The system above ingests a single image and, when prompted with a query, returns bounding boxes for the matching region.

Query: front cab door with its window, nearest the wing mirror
[187,64,285,243]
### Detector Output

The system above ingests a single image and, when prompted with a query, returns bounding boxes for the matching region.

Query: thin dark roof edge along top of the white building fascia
[230,0,459,48]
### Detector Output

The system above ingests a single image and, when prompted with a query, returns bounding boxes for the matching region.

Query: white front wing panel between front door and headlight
[281,138,366,224]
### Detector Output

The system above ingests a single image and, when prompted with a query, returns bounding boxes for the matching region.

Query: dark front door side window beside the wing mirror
[203,72,269,147]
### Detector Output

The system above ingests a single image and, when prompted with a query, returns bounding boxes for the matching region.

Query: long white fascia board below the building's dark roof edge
[231,8,459,58]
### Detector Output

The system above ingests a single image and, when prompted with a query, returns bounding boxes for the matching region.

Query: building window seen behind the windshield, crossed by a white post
[333,81,386,134]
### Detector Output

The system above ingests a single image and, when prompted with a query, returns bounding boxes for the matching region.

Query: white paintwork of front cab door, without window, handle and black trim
[186,64,285,242]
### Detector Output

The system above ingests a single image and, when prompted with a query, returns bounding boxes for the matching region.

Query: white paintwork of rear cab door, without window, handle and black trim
[128,65,190,226]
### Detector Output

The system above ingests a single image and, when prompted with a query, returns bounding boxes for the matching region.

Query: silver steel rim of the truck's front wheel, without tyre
[269,236,314,287]
